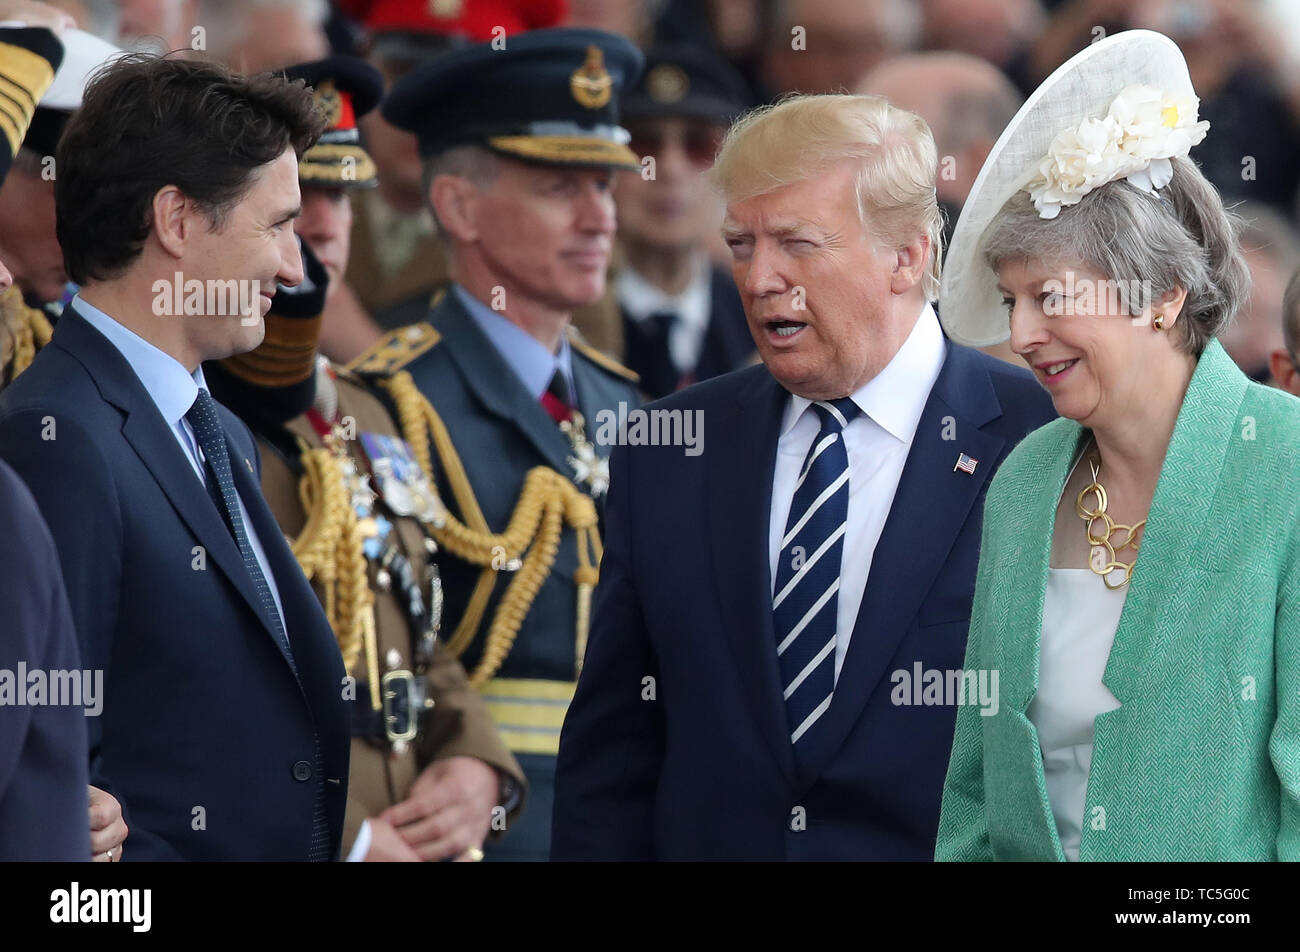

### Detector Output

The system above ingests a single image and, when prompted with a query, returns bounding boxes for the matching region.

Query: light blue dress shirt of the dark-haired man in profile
[73,294,289,632]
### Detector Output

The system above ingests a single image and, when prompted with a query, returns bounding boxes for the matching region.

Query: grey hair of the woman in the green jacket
[980,157,1251,356]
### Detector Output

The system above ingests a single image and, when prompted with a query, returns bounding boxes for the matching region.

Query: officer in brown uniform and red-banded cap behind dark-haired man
[204,56,524,862]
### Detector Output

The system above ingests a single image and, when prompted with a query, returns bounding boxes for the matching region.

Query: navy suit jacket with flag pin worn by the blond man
[551,343,1053,860]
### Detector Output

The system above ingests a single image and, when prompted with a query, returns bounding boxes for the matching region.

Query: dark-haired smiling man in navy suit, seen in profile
[0,56,348,860]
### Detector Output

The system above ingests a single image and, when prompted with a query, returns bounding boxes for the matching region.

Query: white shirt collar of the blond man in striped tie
[781,302,946,443]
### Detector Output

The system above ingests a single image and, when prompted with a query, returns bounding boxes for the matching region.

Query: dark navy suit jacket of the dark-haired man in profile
[0,307,350,860]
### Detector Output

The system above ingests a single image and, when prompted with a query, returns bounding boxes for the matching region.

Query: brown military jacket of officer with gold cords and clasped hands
[257,373,524,856]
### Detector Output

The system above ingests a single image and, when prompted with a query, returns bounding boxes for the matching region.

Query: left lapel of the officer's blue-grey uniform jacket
[434,293,574,473]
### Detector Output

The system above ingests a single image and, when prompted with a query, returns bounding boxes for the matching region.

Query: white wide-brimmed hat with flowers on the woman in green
[939,30,1209,347]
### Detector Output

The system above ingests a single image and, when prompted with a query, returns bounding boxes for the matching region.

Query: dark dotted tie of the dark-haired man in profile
[185,388,329,862]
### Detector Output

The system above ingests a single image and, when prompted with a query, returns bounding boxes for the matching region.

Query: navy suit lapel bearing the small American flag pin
[805,345,1004,780]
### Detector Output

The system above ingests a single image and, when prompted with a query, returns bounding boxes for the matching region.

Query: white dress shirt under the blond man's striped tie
[768,303,948,681]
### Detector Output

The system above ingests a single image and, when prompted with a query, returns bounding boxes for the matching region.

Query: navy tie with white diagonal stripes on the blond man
[772,397,861,761]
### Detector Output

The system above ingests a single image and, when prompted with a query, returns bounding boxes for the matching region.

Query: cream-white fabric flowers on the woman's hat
[1026,86,1210,218]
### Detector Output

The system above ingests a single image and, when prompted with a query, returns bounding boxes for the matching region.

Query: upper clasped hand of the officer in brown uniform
[380,757,501,862]
